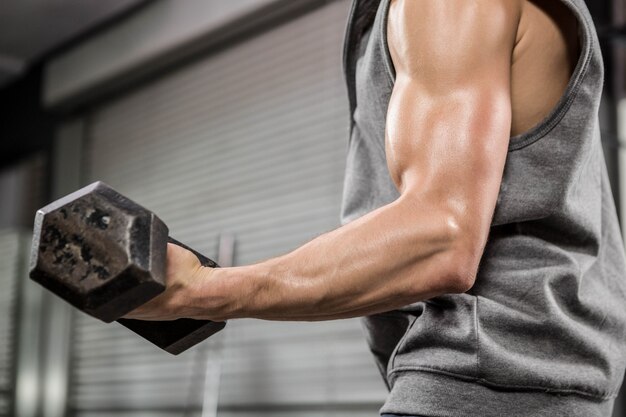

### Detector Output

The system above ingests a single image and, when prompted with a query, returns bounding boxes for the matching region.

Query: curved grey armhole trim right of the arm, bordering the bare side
[509,0,592,152]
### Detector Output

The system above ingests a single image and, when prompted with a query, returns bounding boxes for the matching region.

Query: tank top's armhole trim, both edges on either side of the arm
[380,0,592,152]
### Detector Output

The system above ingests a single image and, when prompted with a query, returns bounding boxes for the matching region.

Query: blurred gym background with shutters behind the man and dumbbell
[0,0,626,417]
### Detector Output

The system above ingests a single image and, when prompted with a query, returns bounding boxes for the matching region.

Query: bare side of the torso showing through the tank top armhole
[511,0,580,136]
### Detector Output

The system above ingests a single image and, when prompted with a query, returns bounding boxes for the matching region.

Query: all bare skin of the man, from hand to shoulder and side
[128,0,577,321]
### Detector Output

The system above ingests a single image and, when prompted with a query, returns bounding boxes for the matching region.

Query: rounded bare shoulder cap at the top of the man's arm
[387,0,525,78]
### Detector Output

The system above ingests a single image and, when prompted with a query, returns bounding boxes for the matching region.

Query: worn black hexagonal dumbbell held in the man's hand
[30,182,226,355]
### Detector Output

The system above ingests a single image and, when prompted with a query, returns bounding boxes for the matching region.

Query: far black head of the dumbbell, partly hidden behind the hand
[117,237,226,355]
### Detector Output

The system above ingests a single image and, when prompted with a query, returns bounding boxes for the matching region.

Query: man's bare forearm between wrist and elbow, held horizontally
[193,193,468,321]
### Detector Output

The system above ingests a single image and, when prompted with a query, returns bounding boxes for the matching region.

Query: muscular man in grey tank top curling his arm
[131,0,626,417]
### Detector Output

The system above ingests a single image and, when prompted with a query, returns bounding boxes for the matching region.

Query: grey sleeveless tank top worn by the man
[342,0,626,417]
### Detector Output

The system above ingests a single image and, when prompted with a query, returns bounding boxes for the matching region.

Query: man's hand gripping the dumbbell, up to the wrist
[124,243,211,321]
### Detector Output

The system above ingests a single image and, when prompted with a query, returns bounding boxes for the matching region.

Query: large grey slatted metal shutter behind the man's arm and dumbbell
[70,0,385,417]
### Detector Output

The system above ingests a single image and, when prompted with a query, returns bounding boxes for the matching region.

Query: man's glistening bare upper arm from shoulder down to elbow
[386,0,516,247]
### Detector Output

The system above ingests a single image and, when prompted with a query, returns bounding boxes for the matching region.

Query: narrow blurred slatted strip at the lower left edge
[0,231,23,417]
